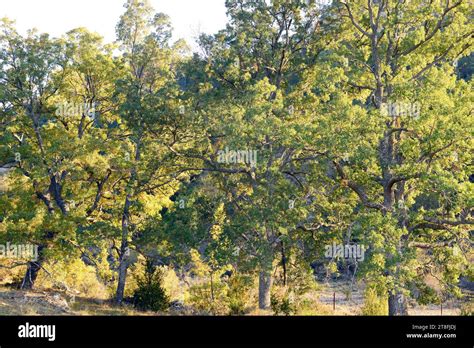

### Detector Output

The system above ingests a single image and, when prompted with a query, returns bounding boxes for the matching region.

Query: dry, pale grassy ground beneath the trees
[0,282,472,316]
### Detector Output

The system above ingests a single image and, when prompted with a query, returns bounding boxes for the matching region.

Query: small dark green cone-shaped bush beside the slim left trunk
[133,261,169,311]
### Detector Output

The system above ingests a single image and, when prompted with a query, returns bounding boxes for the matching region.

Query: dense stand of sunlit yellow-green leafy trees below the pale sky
[0,0,474,315]
